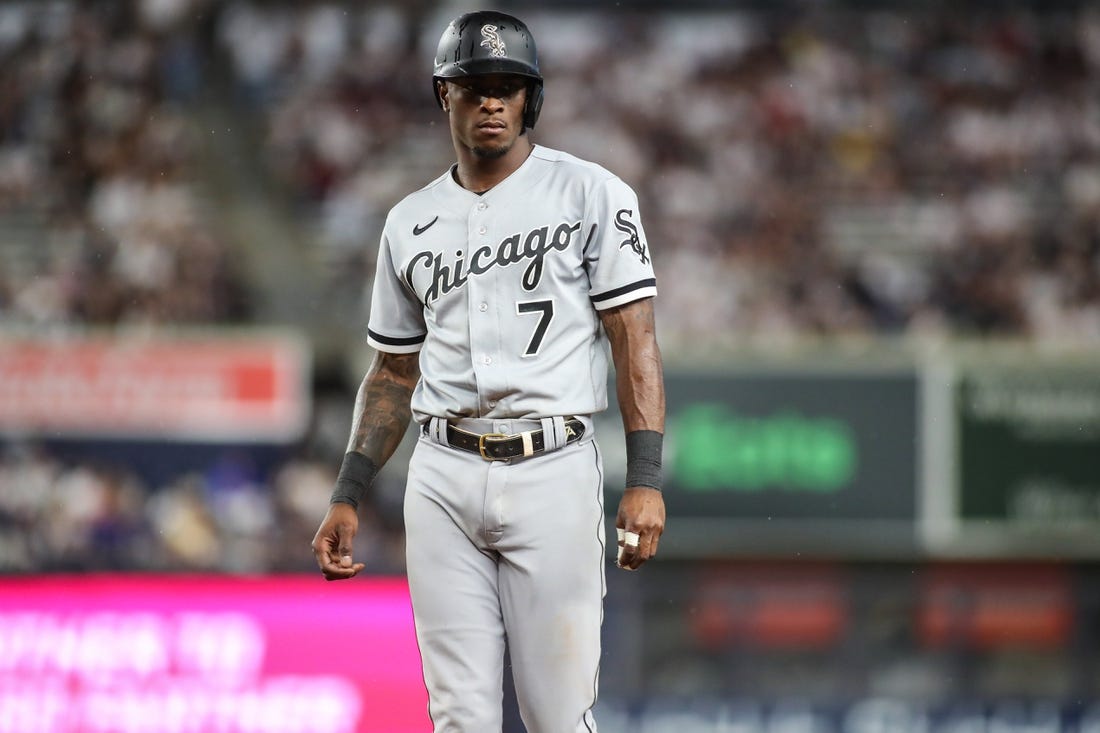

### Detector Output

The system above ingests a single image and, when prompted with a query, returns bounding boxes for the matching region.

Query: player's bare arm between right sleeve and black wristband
[600,298,664,433]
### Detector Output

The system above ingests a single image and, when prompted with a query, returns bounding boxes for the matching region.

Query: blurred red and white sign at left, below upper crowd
[0,331,310,442]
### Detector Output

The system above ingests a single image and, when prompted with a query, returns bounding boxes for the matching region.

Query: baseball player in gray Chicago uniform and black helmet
[312,11,664,733]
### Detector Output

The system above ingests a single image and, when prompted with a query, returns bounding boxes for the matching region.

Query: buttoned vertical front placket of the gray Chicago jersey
[465,199,503,415]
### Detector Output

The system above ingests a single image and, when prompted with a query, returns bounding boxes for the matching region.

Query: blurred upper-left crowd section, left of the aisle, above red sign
[0,1,246,328]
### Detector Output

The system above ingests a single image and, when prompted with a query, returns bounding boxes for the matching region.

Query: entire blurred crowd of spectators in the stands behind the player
[0,0,1100,572]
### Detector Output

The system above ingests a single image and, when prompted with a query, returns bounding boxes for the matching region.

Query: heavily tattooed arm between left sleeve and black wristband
[348,351,420,466]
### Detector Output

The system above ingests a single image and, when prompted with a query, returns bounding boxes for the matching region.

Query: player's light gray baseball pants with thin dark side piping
[405,419,606,733]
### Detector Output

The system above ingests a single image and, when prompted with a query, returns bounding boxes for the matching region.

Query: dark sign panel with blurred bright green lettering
[666,373,917,522]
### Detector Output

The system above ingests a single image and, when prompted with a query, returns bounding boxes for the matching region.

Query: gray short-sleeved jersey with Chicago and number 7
[367,145,657,423]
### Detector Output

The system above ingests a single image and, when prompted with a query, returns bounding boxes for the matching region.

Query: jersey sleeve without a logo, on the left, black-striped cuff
[366,233,428,353]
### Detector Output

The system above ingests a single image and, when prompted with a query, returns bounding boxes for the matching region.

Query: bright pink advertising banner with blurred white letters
[0,576,431,733]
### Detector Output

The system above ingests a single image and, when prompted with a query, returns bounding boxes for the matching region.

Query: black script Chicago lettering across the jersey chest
[405,221,581,306]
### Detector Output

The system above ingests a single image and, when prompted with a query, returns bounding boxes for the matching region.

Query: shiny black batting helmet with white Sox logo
[431,10,542,128]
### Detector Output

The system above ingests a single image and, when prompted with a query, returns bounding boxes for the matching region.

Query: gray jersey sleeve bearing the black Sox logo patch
[582,177,657,310]
